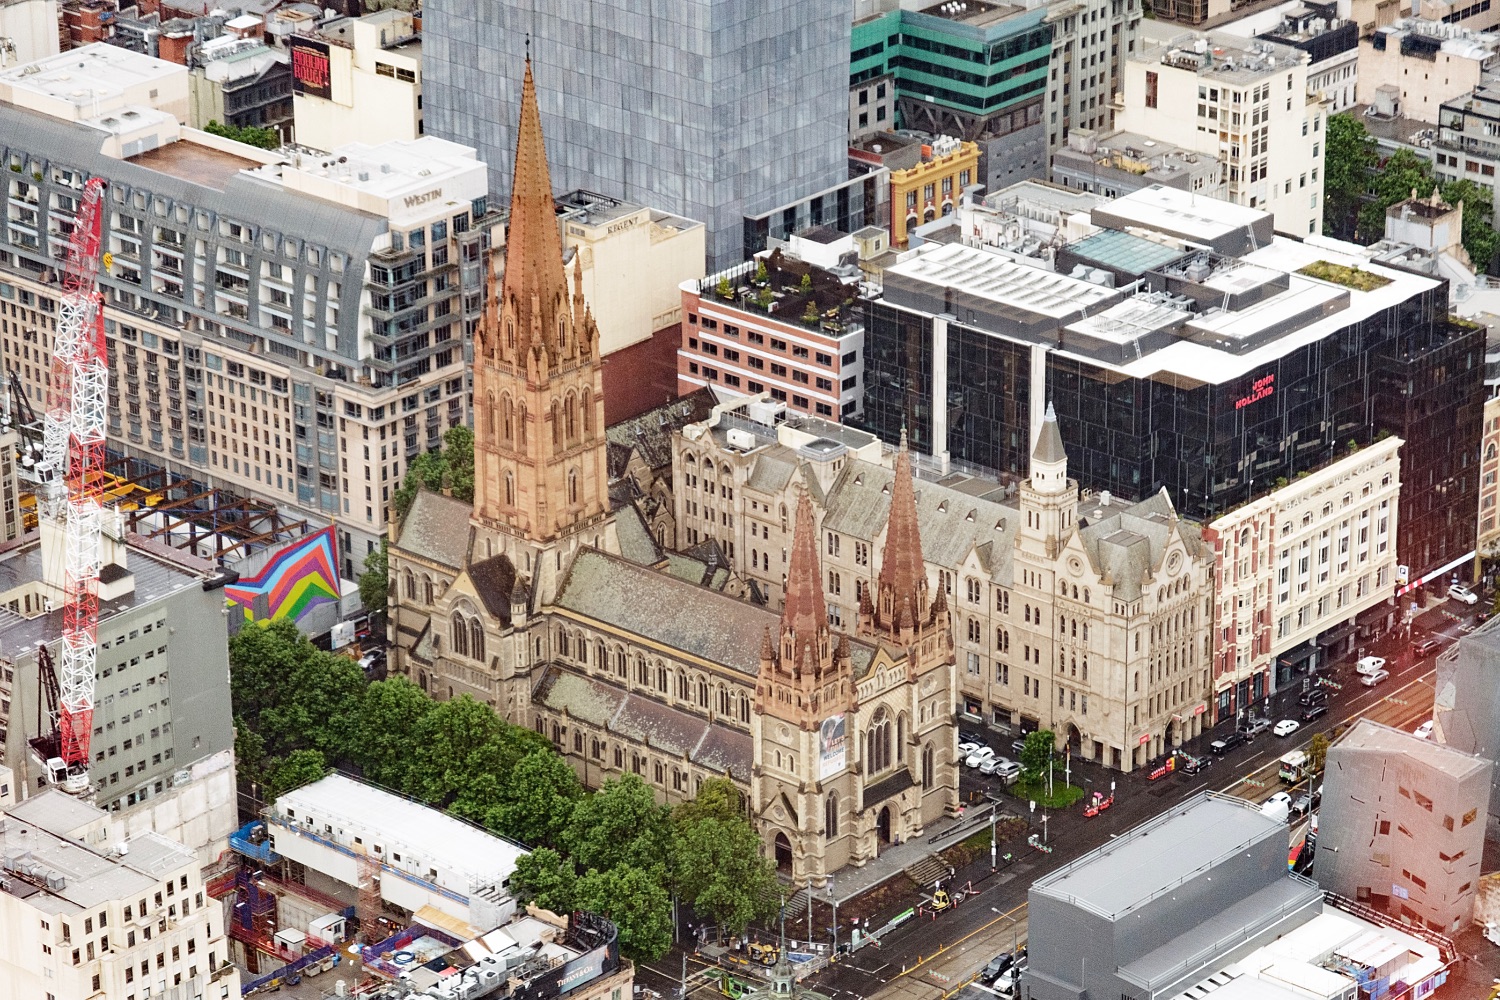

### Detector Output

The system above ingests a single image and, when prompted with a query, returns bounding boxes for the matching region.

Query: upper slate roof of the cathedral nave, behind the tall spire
[554,549,777,678]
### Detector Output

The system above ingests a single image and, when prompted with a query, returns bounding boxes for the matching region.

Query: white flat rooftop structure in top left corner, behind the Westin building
[0,42,188,121]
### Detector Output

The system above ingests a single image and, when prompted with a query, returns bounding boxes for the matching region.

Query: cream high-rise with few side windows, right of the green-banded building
[1115,31,1326,237]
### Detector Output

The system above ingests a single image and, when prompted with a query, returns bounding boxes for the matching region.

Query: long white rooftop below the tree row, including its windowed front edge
[267,774,527,895]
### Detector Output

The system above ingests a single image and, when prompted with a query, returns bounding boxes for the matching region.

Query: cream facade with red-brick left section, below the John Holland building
[1203,438,1403,721]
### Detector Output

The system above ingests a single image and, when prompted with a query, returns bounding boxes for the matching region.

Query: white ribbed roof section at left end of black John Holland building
[885,243,1118,319]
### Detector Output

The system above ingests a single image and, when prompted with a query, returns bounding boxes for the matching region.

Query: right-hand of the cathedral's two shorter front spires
[860,430,954,673]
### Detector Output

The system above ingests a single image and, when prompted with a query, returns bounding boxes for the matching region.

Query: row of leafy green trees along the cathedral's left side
[230,621,776,961]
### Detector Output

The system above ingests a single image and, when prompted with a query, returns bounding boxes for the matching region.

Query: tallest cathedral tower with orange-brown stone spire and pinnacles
[474,58,609,551]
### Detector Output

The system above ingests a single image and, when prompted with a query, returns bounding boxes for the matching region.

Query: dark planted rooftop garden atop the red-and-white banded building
[699,247,858,336]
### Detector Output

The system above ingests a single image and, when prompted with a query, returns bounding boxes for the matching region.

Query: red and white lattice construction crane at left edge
[44,177,110,795]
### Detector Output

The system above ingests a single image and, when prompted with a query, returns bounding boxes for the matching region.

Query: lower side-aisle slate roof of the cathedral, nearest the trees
[531,666,753,781]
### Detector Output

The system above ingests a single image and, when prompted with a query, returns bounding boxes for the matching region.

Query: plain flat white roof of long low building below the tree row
[273,774,527,886]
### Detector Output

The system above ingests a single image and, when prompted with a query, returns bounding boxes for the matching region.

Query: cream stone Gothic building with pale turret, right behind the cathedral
[674,400,1212,771]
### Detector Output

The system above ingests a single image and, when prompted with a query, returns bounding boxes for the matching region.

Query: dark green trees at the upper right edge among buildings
[1323,112,1500,274]
